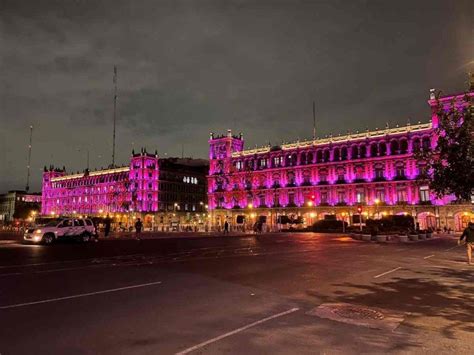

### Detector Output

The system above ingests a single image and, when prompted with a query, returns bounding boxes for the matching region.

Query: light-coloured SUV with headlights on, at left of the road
[23,218,98,244]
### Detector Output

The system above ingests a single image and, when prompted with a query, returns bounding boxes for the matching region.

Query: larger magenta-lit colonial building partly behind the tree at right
[208,90,474,230]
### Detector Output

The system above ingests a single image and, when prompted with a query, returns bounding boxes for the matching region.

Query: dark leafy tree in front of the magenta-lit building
[417,95,474,200]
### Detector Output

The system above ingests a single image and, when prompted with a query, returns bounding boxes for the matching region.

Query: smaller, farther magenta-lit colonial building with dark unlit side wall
[41,149,208,231]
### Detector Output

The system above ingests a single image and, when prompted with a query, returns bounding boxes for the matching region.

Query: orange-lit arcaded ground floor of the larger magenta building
[209,205,474,232]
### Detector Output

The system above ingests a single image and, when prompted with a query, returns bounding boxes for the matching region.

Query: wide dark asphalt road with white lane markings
[0,234,474,355]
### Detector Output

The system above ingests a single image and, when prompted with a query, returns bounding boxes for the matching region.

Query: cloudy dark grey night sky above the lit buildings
[0,0,474,192]
